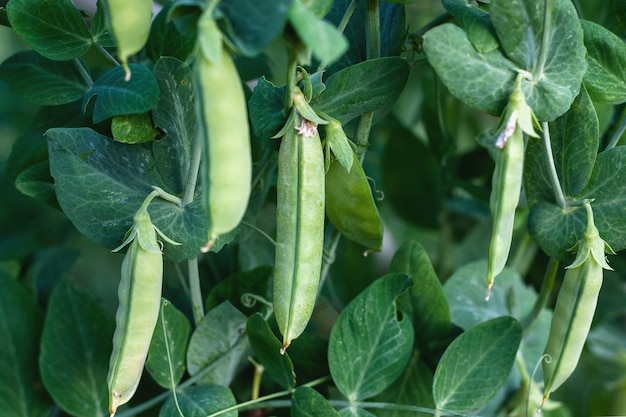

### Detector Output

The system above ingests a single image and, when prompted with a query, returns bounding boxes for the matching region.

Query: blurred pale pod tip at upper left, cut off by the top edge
[106,0,152,81]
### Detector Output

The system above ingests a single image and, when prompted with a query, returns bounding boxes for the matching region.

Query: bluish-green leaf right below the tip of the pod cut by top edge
[83,64,159,123]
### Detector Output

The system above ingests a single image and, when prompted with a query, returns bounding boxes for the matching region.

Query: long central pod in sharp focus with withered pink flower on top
[274,120,324,353]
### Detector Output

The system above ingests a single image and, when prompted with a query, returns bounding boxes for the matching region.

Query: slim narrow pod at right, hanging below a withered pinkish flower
[487,125,524,298]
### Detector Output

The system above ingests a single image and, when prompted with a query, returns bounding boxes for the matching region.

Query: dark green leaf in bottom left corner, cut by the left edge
[0,271,52,417]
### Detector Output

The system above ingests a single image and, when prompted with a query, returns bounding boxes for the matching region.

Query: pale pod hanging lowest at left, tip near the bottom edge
[108,234,163,416]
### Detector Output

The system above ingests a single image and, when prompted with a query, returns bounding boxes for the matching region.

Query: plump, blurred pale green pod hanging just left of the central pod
[195,38,252,252]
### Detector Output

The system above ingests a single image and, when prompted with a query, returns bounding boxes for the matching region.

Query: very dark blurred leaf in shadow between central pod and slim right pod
[379,118,443,228]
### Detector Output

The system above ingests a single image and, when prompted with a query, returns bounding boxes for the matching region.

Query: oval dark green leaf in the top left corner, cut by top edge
[7,0,92,61]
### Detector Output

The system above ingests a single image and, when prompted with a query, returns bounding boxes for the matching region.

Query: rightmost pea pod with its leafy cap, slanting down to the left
[542,203,614,401]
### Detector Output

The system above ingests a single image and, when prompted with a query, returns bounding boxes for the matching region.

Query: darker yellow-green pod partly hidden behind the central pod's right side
[326,152,383,251]
